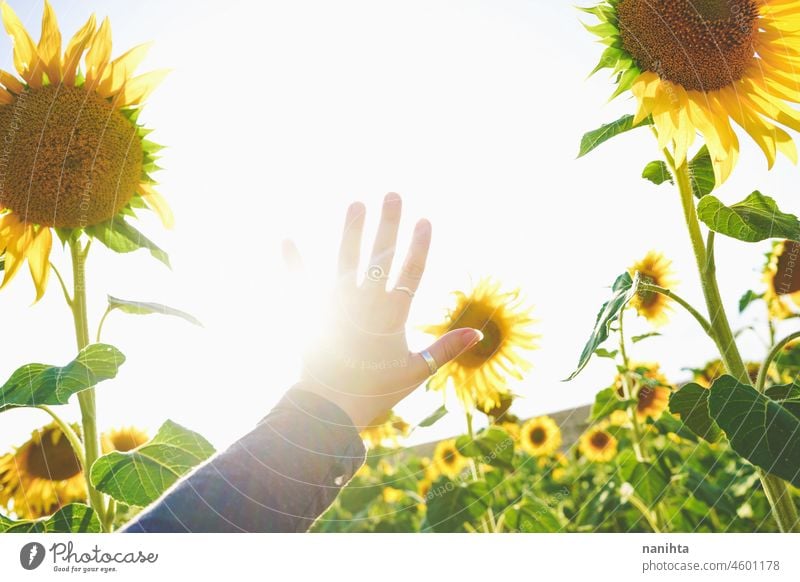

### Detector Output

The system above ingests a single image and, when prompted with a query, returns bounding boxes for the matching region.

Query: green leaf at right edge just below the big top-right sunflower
[697,191,800,242]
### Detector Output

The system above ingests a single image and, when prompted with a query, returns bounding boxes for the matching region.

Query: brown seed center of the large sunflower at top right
[617,0,759,91]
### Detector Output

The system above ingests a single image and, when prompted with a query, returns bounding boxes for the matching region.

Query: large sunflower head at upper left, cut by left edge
[0,0,173,300]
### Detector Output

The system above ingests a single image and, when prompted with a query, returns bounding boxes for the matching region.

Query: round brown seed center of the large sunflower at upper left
[0,85,143,228]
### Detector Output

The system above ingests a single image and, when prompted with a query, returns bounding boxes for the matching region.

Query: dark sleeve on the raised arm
[121,385,364,533]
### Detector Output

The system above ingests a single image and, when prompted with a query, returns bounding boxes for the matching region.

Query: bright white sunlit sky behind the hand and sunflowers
[0,0,800,450]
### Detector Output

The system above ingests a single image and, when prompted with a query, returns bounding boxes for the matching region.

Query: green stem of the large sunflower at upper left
[69,239,107,531]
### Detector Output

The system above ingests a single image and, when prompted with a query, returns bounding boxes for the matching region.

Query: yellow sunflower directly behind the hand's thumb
[423,279,536,412]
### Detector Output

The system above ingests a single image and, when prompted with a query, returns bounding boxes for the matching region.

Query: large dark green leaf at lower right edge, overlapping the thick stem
[708,375,800,487]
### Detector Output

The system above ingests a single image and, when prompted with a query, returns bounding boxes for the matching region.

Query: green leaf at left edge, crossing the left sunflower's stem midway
[0,344,125,411]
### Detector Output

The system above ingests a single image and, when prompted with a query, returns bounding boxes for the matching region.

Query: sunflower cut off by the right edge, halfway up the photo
[764,240,800,319]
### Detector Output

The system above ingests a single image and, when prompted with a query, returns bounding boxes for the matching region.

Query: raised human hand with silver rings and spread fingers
[284,193,483,429]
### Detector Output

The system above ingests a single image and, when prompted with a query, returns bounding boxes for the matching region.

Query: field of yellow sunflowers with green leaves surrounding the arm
[0,0,800,533]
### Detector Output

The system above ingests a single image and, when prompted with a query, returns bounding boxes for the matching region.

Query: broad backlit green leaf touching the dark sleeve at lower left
[90,420,214,506]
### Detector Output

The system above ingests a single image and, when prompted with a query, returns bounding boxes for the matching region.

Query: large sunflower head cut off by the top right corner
[584,0,800,184]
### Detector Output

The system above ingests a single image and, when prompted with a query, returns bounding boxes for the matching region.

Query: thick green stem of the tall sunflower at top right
[664,157,800,532]
